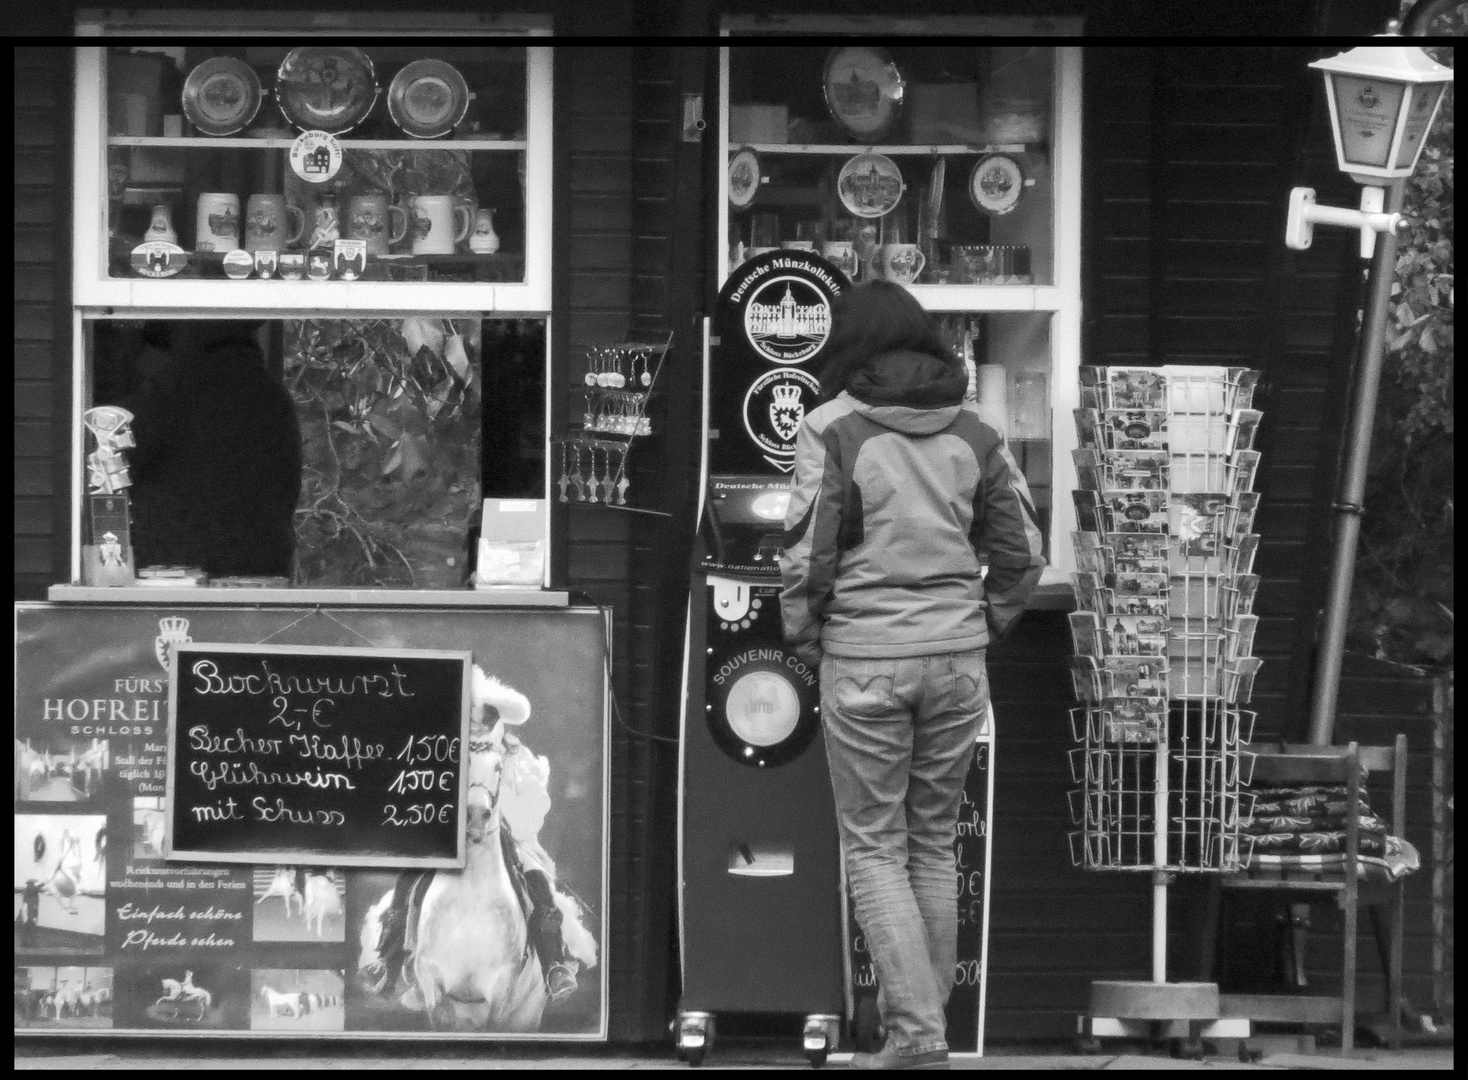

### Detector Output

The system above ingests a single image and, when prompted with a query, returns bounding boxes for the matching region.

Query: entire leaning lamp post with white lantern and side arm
[1285,45,1453,745]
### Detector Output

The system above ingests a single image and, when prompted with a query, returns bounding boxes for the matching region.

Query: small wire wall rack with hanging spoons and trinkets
[552,332,672,512]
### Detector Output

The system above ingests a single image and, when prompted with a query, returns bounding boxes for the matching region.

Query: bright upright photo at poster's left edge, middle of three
[15,814,107,955]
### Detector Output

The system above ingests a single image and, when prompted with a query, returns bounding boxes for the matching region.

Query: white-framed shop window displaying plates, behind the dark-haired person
[713,37,1082,589]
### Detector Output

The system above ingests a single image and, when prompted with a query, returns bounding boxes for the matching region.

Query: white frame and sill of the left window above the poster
[60,18,567,606]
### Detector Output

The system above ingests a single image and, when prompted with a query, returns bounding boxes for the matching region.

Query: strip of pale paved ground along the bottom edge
[15,1039,1453,1071]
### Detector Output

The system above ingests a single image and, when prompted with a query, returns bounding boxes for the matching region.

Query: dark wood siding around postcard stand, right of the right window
[988,47,1368,1040]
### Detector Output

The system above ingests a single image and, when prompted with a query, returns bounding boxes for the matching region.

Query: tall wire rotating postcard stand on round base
[1070,367,1260,1057]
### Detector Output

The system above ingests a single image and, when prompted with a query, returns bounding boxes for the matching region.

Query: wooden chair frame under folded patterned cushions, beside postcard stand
[1202,735,1406,1054]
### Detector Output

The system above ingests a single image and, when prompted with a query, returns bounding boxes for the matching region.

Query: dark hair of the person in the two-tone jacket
[821,280,963,401]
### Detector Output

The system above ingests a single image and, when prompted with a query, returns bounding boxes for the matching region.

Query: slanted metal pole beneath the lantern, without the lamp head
[1309,180,1405,745]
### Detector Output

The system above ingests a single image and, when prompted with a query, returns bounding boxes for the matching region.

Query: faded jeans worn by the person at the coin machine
[821,649,989,1055]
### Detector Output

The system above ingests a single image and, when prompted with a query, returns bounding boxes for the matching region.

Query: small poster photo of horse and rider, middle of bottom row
[113,960,250,1032]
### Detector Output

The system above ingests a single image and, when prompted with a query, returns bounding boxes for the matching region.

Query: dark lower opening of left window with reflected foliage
[78,315,545,588]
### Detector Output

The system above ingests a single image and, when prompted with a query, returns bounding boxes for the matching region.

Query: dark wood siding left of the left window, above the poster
[15,48,72,600]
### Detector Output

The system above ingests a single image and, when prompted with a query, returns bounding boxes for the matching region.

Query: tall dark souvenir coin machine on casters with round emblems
[675,249,847,1065]
